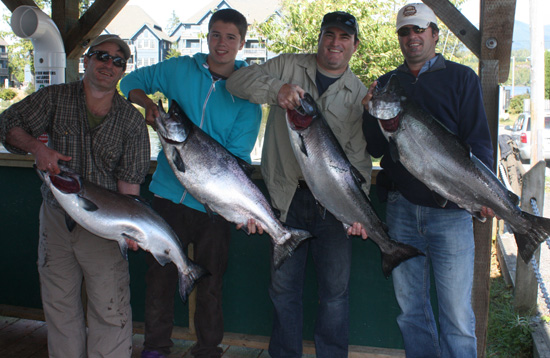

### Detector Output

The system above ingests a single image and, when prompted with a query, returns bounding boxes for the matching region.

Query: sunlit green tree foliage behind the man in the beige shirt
[254,0,470,85]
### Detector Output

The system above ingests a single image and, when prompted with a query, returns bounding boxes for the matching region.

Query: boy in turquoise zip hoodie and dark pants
[120,9,261,358]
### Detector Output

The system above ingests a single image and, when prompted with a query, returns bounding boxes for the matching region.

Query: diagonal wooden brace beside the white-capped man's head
[422,0,481,58]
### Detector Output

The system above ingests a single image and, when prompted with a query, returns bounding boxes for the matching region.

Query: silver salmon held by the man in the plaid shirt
[37,170,208,302]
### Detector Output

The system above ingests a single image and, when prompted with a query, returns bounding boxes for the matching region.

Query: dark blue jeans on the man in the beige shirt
[269,188,351,358]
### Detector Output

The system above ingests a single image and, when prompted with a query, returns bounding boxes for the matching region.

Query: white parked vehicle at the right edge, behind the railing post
[504,112,550,161]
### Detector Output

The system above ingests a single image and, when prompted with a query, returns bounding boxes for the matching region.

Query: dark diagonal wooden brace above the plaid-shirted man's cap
[63,0,128,59]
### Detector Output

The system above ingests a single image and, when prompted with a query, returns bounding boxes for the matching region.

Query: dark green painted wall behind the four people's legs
[0,166,410,348]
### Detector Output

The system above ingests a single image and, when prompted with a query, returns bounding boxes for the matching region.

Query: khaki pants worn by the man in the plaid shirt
[38,204,132,358]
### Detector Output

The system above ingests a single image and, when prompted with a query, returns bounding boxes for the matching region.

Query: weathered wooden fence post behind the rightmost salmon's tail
[514,160,546,314]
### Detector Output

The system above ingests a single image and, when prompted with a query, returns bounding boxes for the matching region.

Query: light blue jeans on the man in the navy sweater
[387,191,477,358]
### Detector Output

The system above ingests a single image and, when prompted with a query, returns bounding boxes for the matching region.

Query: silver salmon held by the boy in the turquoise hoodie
[156,101,311,268]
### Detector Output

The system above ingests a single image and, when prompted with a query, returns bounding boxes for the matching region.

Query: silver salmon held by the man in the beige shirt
[286,94,423,277]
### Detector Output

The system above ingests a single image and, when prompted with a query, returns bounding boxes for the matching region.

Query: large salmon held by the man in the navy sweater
[369,76,550,263]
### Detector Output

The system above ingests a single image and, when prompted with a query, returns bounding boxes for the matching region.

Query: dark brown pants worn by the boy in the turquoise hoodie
[143,197,231,357]
